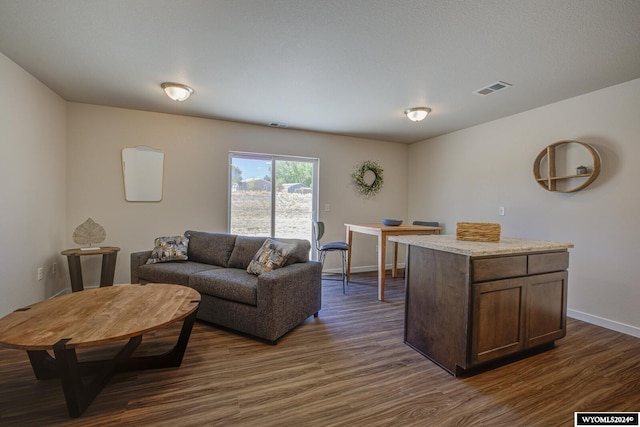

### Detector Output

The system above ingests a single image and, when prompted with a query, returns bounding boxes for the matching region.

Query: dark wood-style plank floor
[0,274,640,427]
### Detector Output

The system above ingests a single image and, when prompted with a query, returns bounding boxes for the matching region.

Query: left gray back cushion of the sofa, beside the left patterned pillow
[184,230,237,267]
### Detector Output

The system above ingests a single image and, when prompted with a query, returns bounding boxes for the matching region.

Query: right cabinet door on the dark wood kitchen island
[526,271,568,347]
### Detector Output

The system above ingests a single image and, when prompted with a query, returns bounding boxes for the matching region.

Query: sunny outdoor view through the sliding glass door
[229,153,318,241]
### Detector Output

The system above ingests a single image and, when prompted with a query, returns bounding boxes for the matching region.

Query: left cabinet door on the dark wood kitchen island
[470,277,527,365]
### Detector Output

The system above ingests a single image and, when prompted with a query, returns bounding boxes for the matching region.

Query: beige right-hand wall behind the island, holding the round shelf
[409,80,640,336]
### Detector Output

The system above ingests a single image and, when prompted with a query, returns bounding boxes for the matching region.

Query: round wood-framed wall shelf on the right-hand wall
[533,141,601,193]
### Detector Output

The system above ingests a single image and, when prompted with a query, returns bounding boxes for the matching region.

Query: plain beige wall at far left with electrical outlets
[0,54,66,316]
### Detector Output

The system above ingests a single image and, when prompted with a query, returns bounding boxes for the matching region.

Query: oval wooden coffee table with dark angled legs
[0,284,200,417]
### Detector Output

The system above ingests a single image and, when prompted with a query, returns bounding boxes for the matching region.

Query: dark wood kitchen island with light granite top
[390,235,573,375]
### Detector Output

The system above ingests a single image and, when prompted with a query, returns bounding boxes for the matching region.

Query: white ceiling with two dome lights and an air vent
[0,0,640,143]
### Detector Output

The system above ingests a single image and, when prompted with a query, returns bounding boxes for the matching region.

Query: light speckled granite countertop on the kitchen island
[389,234,573,256]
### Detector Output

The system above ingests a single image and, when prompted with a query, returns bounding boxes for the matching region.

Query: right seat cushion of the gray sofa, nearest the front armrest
[189,268,258,306]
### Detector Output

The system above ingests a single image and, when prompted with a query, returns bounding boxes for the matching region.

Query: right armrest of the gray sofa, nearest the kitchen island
[257,261,322,340]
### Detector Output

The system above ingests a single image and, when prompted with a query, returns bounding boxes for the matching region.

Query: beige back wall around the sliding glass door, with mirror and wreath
[67,103,409,286]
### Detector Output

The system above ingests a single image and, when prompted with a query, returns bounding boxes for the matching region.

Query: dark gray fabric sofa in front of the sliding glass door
[131,231,322,343]
